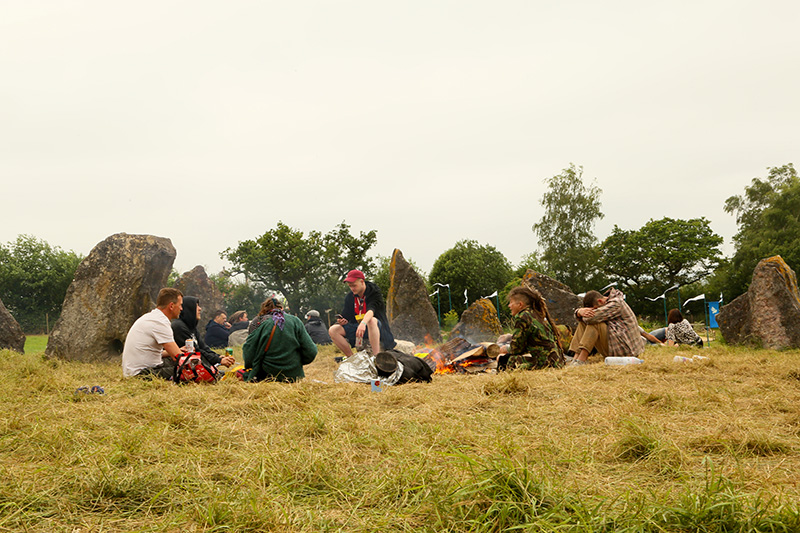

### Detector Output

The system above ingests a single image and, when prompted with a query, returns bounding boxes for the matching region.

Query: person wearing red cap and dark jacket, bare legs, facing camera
[328,270,396,357]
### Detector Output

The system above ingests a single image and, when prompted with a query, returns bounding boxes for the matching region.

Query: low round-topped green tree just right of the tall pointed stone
[428,240,513,314]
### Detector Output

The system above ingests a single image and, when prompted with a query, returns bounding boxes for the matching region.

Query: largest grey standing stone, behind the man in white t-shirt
[45,233,176,361]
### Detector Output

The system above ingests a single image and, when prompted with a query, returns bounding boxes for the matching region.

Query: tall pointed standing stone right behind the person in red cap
[386,249,441,344]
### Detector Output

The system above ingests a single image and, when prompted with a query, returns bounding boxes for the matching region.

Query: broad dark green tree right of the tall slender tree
[600,217,723,309]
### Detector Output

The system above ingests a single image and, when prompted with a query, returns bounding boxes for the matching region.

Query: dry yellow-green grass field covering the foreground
[0,338,800,532]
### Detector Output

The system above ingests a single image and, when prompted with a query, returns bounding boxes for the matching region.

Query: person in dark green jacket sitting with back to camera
[242,298,317,381]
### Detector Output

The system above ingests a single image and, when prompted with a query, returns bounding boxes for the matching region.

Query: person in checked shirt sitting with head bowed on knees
[569,288,645,365]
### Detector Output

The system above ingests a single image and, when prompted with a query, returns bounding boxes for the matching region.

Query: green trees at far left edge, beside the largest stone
[0,235,82,333]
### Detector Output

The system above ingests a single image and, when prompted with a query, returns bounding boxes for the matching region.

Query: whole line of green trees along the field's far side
[0,163,800,333]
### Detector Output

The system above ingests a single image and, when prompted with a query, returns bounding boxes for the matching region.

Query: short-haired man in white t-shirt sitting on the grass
[122,288,183,379]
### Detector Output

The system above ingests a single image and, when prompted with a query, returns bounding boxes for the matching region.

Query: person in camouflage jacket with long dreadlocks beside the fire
[497,287,564,370]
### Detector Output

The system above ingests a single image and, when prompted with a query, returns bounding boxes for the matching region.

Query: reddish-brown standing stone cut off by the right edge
[717,255,800,350]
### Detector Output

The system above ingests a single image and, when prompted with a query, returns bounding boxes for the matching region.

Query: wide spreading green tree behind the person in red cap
[220,222,377,314]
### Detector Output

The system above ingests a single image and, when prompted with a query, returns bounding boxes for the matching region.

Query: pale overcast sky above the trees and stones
[0,0,800,280]
